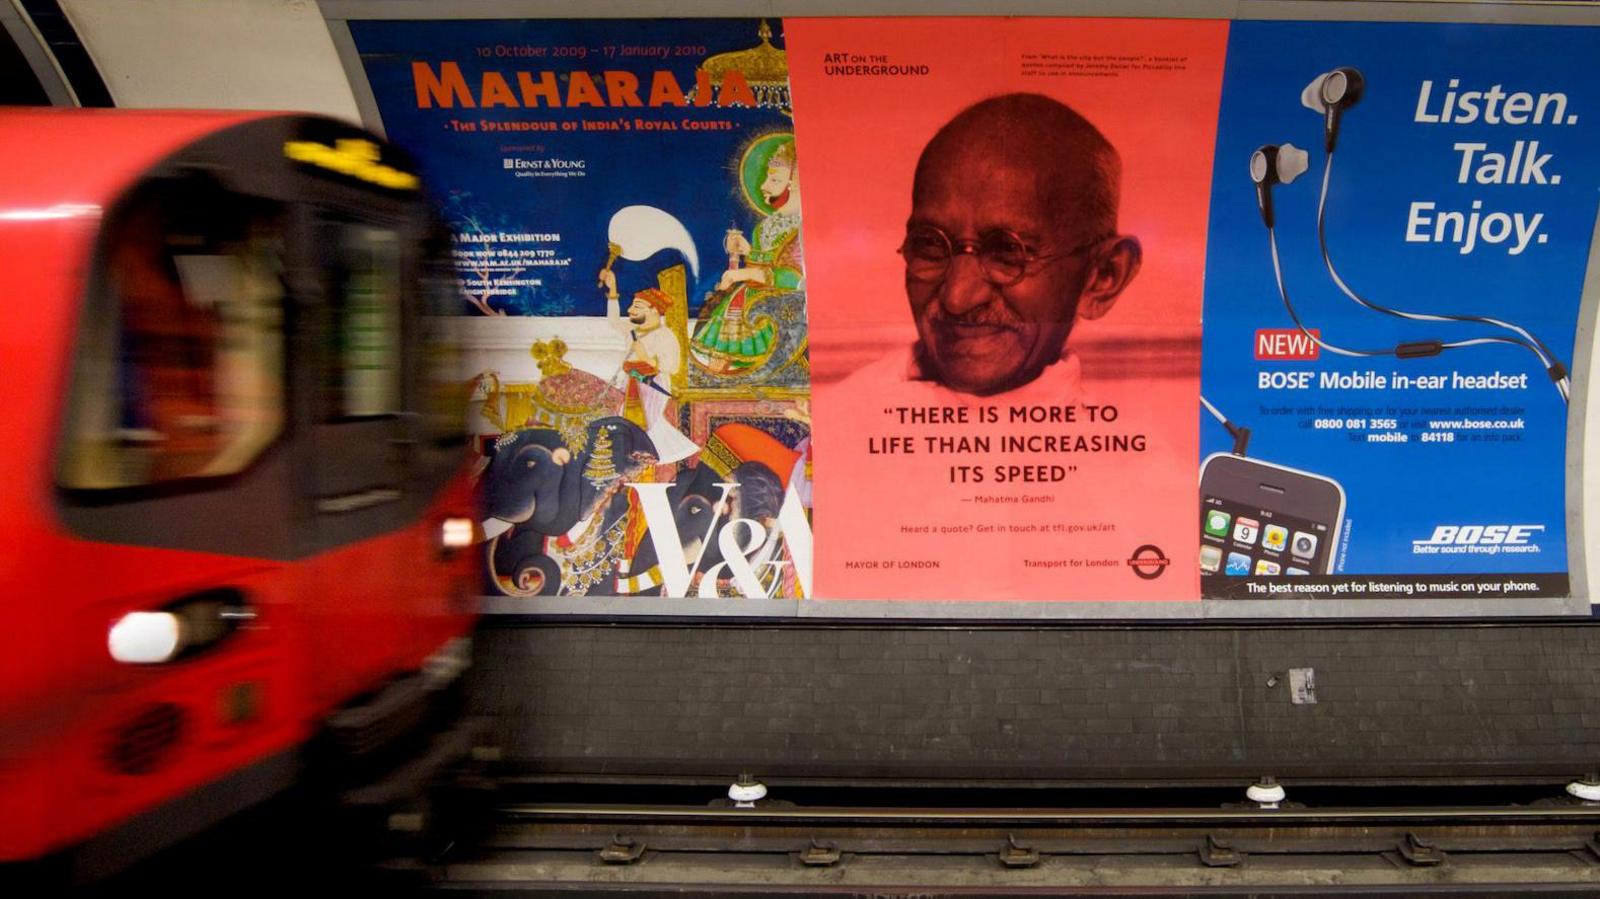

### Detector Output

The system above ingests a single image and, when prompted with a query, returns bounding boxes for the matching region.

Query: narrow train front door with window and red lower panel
[302,206,427,699]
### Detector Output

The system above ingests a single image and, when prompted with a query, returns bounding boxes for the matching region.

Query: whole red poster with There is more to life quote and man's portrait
[786,19,1229,600]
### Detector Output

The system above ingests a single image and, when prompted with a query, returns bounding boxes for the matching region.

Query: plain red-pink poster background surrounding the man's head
[784,18,1227,600]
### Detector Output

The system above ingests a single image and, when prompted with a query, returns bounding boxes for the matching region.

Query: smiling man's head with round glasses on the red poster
[901,93,1141,397]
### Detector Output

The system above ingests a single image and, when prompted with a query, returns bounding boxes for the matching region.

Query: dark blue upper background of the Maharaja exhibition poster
[350,19,792,315]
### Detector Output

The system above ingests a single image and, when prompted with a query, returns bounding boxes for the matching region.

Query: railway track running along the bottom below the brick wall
[396,780,1600,896]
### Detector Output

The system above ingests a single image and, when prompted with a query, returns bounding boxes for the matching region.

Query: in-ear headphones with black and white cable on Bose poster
[1250,66,1571,403]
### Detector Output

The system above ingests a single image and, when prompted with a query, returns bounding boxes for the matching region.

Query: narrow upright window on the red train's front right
[326,222,403,421]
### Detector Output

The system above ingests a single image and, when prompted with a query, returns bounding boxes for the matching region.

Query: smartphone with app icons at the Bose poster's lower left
[1200,453,1344,585]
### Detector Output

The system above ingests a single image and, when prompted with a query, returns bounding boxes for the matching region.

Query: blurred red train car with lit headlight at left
[0,109,477,877]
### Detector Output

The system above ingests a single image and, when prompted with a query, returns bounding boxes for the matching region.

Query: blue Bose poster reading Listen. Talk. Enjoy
[1198,22,1600,601]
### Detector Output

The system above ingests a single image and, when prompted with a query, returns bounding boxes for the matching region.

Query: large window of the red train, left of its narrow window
[58,179,285,489]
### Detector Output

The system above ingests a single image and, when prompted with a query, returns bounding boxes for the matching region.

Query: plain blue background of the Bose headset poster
[1200,22,1600,574]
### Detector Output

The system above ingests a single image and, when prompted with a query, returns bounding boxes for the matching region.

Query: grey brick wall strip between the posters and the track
[472,619,1600,781]
